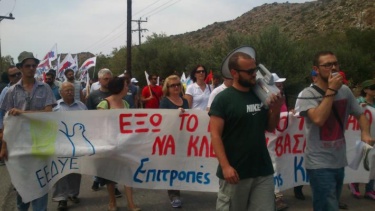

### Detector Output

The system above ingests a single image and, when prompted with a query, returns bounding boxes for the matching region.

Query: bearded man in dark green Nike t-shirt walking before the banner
[209,47,283,211]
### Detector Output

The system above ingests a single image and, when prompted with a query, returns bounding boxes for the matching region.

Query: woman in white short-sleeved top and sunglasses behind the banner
[184,65,212,110]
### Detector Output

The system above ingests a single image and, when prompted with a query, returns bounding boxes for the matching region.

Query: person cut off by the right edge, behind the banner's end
[349,79,375,200]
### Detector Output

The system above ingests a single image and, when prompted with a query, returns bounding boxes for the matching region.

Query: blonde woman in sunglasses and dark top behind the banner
[160,75,189,208]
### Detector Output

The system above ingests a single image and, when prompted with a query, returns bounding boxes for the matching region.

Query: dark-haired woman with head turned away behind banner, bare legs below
[97,76,141,211]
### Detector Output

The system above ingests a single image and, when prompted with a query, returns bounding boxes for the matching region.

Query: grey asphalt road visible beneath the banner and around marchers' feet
[0,166,375,211]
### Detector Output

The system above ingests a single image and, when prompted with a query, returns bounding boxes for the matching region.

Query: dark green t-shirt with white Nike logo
[209,87,274,179]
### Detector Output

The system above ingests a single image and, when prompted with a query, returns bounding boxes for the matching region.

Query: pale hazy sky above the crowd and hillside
[0,0,310,62]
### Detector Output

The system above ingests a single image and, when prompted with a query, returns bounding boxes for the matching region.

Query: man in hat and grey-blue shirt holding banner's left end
[0,51,56,211]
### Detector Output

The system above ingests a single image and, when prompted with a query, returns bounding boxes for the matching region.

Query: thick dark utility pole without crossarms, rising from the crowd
[126,0,132,77]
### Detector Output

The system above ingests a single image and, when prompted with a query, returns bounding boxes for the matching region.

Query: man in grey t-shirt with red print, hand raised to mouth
[295,51,374,210]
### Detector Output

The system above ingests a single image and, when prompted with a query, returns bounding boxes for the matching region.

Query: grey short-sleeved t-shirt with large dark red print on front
[295,85,363,169]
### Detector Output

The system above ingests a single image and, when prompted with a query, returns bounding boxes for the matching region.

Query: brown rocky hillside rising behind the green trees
[171,0,375,46]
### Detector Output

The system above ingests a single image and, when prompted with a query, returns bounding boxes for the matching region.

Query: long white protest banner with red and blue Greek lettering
[4,108,375,202]
